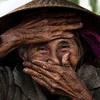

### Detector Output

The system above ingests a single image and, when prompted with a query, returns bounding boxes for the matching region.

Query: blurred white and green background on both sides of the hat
[0,0,100,17]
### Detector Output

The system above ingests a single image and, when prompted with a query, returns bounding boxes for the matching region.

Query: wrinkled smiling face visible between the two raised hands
[19,33,79,70]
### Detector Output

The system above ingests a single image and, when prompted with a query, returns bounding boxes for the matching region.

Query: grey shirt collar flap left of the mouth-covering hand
[13,65,47,100]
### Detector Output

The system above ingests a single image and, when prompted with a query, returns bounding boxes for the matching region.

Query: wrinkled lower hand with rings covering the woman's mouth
[24,54,92,100]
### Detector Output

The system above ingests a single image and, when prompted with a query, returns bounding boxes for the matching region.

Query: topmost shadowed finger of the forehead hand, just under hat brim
[19,11,76,28]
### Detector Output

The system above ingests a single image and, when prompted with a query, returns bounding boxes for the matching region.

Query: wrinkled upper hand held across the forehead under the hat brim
[0,12,83,57]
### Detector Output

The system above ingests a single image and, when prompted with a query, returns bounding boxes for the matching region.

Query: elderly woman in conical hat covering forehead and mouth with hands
[0,0,100,100]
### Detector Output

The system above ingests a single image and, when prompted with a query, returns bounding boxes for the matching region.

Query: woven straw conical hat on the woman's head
[0,0,100,34]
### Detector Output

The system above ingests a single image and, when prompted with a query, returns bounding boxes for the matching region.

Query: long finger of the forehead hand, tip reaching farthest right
[33,19,83,33]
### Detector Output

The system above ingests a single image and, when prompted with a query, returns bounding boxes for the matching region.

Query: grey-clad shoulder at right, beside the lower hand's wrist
[77,64,100,90]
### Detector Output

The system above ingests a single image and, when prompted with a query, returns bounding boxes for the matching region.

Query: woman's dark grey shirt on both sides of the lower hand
[0,65,100,100]
